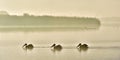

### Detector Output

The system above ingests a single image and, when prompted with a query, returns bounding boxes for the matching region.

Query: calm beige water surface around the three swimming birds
[0,21,120,60]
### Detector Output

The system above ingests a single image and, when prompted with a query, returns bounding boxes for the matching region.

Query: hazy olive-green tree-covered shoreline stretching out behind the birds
[0,10,100,28]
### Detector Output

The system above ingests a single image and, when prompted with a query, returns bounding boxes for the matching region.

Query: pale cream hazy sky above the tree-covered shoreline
[0,0,120,17]
